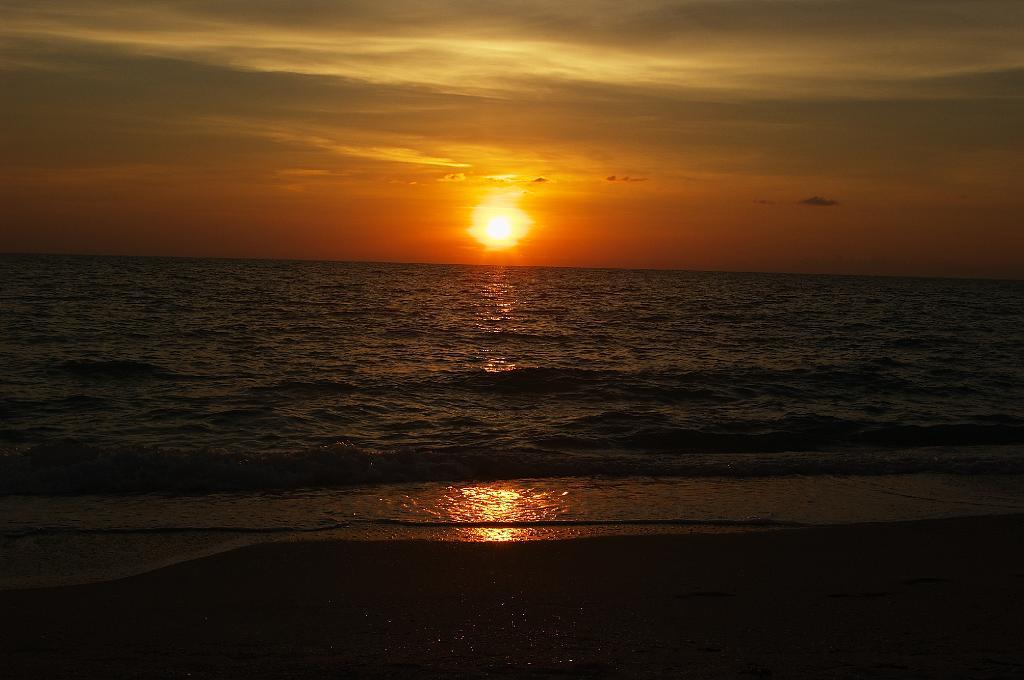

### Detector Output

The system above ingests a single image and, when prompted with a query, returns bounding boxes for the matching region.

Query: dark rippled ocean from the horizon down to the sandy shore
[0,255,1024,586]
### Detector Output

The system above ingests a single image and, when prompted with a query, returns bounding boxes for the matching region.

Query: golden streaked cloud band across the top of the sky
[0,0,1021,100]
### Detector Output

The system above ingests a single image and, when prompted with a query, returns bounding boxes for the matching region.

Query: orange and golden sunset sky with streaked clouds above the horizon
[0,0,1024,278]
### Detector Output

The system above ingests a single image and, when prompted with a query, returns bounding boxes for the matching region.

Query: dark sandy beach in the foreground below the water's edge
[0,516,1024,679]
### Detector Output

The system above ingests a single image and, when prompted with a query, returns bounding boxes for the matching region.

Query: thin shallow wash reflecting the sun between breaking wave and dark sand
[0,474,1024,589]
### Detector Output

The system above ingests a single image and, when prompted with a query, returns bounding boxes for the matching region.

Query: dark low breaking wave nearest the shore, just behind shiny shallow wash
[0,441,1024,495]
